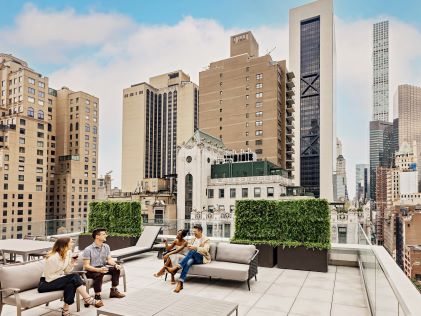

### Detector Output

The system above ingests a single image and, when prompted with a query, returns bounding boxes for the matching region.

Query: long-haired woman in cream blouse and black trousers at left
[38,237,104,316]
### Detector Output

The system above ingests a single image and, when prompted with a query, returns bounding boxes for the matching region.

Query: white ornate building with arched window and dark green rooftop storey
[177,130,296,237]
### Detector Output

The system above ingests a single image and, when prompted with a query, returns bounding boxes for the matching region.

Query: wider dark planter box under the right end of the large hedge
[278,246,328,272]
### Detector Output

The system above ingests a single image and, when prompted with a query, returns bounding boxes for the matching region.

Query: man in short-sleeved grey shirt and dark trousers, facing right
[83,228,125,300]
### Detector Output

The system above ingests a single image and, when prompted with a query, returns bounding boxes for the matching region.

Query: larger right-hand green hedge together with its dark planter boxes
[232,199,330,272]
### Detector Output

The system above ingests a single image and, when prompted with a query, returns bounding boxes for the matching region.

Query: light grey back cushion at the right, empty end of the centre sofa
[216,243,256,264]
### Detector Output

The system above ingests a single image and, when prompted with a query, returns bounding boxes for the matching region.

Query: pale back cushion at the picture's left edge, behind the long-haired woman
[0,260,44,295]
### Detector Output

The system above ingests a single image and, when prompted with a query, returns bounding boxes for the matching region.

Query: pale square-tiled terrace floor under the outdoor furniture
[2,252,370,316]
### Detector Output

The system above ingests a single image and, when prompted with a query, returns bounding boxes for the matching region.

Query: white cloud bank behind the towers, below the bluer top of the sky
[0,5,421,200]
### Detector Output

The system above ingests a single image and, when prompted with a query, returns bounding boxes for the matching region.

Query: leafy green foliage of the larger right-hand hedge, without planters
[232,199,331,249]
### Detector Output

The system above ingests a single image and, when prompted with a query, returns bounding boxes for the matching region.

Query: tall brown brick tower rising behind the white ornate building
[199,32,295,177]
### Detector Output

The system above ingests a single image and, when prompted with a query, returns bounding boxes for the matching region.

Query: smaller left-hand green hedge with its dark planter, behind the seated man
[79,201,142,250]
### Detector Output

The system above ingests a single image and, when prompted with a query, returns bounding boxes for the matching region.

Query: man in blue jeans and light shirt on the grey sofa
[166,224,211,293]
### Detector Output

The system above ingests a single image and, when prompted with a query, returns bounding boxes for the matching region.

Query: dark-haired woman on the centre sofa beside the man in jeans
[154,229,188,284]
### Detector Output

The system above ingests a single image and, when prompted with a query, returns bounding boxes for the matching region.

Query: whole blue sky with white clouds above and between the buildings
[0,0,421,198]
